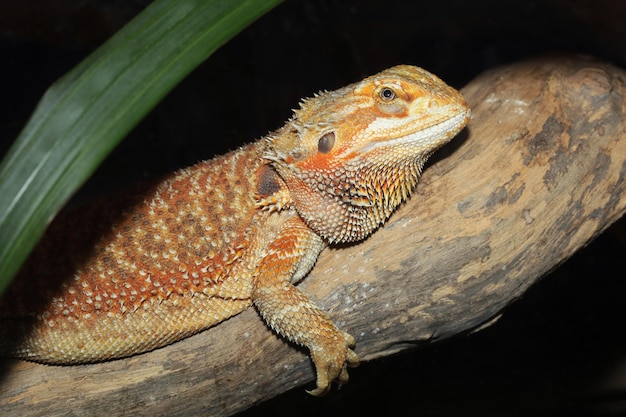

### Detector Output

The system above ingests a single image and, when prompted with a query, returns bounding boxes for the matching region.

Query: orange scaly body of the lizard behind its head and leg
[0,141,272,363]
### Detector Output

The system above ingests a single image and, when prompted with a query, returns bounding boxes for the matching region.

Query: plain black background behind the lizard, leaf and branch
[0,0,626,416]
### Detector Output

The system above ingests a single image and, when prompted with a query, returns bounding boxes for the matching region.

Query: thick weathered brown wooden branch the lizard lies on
[0,56,626,416]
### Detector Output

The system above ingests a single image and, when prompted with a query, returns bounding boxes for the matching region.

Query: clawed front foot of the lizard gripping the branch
[307,332,359,397]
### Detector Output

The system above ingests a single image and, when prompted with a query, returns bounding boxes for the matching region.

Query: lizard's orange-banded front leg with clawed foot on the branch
[252,217,359,395]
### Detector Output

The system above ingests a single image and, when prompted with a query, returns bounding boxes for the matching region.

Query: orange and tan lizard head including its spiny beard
[264,65,470,243]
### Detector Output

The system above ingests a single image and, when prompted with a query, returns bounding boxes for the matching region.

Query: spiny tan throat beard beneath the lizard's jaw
[291,152,425,243]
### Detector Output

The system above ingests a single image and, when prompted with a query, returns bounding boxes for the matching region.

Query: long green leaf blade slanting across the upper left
[0,0,281,294]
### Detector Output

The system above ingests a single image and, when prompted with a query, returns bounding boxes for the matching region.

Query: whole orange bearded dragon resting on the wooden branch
[0,65,470,395]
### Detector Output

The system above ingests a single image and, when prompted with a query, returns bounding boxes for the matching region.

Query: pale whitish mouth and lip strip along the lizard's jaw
[359,108,470,153]
